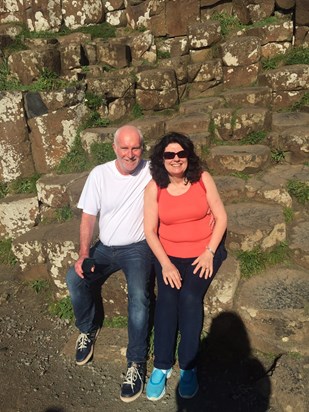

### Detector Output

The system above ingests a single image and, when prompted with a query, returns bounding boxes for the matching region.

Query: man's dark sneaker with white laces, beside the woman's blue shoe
[120,362,146,402]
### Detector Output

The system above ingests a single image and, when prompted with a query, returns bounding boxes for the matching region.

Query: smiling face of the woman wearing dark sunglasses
[163,143,188,177]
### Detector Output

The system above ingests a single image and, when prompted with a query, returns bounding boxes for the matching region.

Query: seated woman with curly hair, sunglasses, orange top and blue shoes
[144,133,227,400]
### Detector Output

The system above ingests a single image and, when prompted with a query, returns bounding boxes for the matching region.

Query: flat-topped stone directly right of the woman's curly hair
[206,145,271,174]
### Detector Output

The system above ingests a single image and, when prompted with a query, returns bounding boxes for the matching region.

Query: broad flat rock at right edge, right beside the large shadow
[236,267,309,356]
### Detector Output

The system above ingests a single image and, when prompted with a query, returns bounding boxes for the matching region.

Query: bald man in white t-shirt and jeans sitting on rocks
[67,125,152,402]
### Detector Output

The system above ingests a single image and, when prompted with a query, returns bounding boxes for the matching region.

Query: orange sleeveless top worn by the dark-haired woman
[158,181,212,258]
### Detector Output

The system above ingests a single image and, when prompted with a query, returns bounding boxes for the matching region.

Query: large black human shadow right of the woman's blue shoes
[176,312,271,412]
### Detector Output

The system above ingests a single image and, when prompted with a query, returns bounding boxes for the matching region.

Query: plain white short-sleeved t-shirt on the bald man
[78,160,151,246]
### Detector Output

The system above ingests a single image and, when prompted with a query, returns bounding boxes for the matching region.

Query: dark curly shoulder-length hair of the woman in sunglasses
[150,132,203,188]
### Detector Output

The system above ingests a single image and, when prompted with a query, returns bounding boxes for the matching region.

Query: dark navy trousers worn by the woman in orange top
[154,243,227,369]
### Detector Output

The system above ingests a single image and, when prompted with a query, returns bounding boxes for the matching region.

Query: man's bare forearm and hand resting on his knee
[74,212,97,278]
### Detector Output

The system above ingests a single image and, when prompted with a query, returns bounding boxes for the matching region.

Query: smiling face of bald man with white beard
[113,128,143,175]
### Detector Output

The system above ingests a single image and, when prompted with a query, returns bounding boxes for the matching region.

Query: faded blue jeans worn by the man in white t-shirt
[67,240,152,362]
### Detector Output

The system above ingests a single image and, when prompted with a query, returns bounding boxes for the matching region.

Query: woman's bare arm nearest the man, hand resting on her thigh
[144,180,181,289]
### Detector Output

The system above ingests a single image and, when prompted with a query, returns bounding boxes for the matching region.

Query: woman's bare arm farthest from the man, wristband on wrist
[193,172,227,278]
